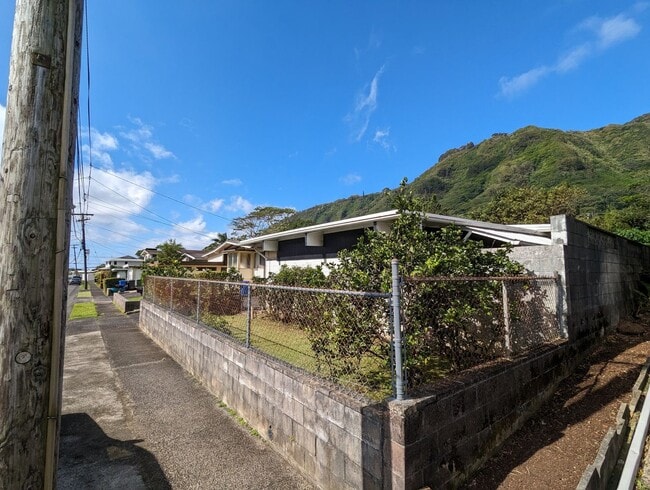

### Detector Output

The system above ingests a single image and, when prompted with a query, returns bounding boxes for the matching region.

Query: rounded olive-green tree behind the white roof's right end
[472,184,586,224]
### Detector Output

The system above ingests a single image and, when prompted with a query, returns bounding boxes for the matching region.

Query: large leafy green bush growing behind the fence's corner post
[322,181,523,384]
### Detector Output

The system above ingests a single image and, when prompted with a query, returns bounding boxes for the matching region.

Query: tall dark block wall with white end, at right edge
[551,216,650,339]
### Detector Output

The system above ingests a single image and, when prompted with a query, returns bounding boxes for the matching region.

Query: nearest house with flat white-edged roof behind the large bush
[235,210,551,278]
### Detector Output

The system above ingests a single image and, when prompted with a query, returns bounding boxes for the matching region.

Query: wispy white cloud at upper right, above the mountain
[499,10,643,98]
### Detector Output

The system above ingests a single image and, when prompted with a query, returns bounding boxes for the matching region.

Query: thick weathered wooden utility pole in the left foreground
[0,0,83,489]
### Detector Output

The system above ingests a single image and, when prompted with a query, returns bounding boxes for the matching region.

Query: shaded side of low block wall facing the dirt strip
[390,343,579,490]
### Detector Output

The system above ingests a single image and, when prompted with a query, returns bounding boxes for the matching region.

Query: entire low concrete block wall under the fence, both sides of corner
[140,301,585,490]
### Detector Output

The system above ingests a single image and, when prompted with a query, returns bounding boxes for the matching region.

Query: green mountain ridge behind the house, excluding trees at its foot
[281,113,650,229]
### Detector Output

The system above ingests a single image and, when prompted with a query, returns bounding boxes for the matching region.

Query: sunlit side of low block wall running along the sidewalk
[140,301,390,489]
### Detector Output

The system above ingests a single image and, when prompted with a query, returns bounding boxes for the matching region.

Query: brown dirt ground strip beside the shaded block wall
[465,311,650,490]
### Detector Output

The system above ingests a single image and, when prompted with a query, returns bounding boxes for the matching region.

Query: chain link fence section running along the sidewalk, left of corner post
[144,277,393,399]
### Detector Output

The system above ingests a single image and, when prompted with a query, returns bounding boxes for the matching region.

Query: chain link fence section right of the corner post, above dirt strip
[402,276,563,388]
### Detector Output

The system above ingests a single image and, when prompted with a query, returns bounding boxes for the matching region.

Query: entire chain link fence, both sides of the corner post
[144,276,562,399]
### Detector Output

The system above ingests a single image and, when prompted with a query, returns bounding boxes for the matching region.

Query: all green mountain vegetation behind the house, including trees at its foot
[280,114,650,243]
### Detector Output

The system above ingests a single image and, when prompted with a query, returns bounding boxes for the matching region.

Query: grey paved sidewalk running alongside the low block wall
[57,285,314,489]
